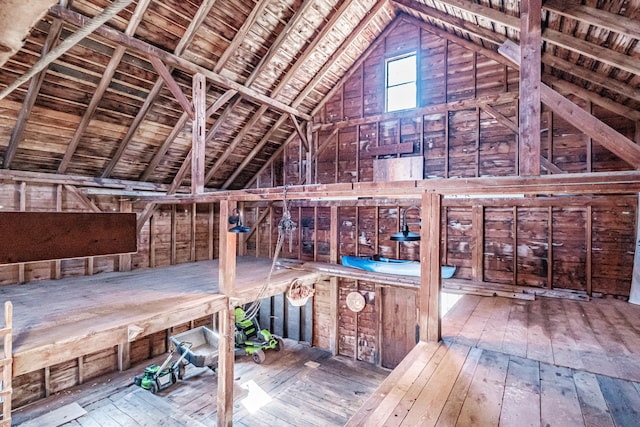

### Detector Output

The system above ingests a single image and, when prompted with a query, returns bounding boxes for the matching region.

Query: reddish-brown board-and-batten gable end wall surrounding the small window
[251,20,637,366]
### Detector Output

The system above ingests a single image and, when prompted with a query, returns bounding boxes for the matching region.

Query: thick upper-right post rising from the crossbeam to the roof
[518,0,542,176]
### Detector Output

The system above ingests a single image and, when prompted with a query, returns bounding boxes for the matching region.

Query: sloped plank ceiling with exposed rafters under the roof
[0,0,640,189]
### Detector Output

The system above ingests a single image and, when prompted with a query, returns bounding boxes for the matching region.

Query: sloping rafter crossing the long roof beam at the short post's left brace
[102,0,216,178]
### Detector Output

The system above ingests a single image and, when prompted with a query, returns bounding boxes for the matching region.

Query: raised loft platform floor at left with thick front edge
[0,257,315,376]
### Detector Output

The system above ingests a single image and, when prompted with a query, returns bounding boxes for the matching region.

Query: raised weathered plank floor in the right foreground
[347,295,640,427]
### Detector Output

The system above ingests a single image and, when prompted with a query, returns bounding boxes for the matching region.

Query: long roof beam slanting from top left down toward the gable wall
[49,6,311,120]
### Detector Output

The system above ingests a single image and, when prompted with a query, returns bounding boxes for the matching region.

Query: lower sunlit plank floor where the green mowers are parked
[17,340,389,427]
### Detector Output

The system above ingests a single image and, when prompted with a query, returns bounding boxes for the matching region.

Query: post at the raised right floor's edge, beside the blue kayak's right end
[418,193,442,342]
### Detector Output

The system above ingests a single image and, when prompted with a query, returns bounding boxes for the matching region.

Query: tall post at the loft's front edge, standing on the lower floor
[217,200,237,426]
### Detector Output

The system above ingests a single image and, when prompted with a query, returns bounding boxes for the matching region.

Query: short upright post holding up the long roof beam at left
[191,73,207,194]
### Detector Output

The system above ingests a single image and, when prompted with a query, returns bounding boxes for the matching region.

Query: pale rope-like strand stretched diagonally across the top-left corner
[0,0,133,100]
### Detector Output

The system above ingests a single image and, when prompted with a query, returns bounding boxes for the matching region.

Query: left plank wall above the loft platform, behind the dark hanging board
[0,182,218,285]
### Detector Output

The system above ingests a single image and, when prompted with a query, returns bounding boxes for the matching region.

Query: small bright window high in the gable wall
[386,53,418,111]
